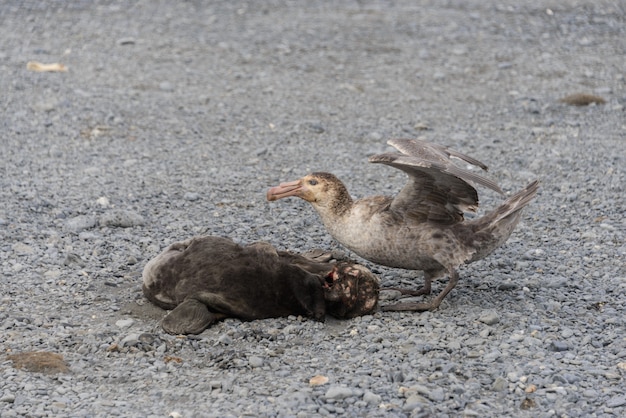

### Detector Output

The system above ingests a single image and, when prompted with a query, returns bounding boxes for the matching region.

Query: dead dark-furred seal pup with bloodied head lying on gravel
[143,236,379,334]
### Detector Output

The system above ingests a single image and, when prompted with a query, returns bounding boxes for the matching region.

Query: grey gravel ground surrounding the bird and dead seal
[0,0,626,417]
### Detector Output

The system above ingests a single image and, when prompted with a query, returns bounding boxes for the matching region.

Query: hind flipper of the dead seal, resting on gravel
[161,299,224,334]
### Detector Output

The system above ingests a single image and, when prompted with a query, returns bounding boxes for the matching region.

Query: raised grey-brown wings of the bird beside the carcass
[369,139,502,224]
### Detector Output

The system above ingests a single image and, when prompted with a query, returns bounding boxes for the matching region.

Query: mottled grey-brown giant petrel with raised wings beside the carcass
[267,139,539,311]
